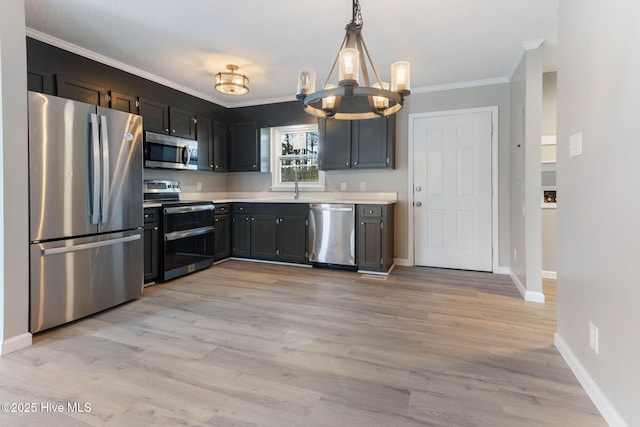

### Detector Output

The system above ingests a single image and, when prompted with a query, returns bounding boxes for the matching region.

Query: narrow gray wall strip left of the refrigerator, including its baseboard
[0,0,31,353]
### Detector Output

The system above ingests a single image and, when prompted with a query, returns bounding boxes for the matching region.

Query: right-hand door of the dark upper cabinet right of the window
[351,116,395,168]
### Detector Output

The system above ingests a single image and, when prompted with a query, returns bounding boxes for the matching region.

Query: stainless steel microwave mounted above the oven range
[144,131,198,170]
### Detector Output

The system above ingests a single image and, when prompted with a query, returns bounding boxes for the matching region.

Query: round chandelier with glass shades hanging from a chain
[296,0,411,120]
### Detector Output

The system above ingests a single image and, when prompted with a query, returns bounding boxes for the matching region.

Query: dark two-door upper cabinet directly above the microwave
[138,98,196,139]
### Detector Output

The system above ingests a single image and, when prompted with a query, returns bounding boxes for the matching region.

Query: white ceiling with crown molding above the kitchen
[25,0,558,107]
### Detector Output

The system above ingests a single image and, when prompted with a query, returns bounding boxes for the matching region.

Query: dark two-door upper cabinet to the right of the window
[318,115,396,170]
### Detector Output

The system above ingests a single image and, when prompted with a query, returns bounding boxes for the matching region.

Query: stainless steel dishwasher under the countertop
[309,203,356,266]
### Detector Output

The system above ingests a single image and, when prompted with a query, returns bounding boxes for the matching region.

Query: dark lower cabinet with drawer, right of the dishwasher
[356,204,394,272]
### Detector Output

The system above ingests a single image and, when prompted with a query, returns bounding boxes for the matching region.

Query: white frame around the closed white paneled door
[407,105,500,273]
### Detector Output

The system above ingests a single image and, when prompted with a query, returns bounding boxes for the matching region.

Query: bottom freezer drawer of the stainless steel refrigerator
[29,230,143,333]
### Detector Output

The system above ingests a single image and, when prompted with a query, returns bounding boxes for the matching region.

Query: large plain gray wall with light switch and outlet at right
[557,0,640,426]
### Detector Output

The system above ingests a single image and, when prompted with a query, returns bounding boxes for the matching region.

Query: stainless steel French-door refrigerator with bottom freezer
[29,92,143,333]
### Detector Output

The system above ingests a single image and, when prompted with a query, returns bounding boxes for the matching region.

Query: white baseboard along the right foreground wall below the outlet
[553,332,627,427]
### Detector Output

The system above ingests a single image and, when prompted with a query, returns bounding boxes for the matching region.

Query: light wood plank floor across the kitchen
[0,261,606,427]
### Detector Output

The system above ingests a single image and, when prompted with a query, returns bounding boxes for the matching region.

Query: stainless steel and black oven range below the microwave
[144,180,215,282]
